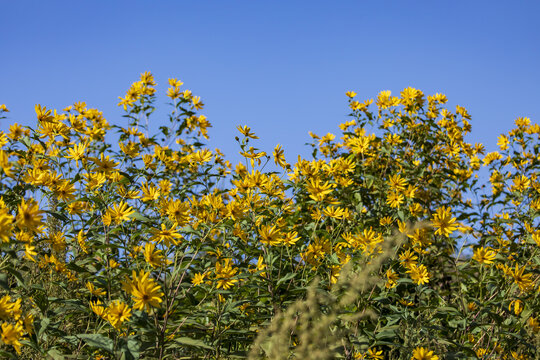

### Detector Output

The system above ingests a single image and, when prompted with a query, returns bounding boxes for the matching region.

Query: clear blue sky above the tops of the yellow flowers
[0,0,540,166]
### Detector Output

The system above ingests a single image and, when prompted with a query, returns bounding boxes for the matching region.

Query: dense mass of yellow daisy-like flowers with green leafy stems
[0,72,540,360]
